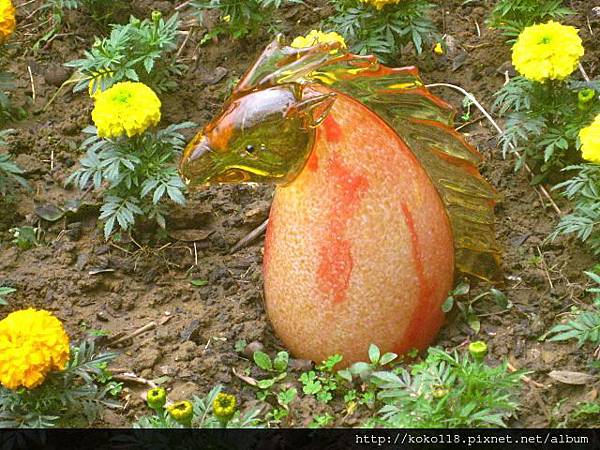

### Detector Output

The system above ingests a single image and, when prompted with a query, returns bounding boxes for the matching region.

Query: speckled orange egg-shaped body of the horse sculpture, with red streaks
[263,87,454,364]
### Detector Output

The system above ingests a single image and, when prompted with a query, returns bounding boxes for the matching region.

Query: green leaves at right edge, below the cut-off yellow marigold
[550,164,600,255]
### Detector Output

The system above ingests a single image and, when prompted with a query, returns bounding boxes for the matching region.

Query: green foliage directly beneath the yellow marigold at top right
[493,76,600,184]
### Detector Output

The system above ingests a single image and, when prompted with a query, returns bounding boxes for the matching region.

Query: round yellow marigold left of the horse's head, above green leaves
[92,81,160,138]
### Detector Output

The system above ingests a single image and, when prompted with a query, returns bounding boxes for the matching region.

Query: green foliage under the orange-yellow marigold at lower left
[0,341,118,428]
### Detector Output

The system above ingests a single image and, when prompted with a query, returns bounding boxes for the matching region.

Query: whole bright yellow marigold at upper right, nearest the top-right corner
[512,20,584,82]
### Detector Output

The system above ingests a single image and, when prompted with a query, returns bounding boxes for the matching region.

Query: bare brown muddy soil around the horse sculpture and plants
[0,0,600,427]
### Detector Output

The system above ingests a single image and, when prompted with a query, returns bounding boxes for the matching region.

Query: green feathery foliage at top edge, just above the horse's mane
[326,0,438,62]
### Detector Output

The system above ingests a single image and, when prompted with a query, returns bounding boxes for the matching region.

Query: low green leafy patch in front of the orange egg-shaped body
[241,345,524,428]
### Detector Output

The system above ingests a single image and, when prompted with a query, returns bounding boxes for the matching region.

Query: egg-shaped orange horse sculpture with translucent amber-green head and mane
[180,37,499,364]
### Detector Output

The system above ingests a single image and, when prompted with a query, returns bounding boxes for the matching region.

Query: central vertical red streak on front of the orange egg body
[317,153,369,304]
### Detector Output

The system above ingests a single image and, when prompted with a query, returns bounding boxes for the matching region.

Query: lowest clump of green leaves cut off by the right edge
[547,272,600,347]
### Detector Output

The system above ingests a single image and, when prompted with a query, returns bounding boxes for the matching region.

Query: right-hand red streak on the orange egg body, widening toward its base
[396,202,444,354]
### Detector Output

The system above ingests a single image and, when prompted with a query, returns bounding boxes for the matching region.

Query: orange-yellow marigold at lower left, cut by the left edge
[0,308,69,389]
